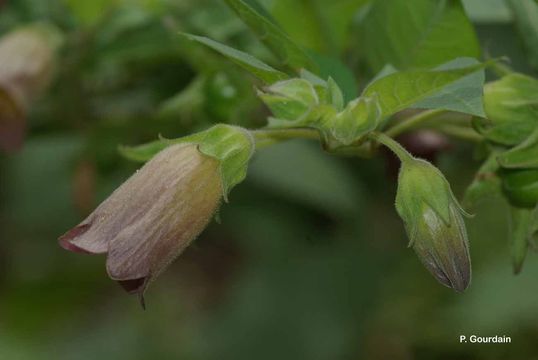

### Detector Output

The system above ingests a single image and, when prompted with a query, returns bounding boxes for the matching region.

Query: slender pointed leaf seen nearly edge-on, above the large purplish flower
[183,34,288,84]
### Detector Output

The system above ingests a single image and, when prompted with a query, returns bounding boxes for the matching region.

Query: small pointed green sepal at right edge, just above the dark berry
[498,126,538,169]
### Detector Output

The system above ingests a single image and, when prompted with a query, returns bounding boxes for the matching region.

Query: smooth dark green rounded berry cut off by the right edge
[500,170,538,208]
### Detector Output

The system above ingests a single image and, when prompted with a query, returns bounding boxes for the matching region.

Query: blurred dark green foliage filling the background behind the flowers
[0,0,538,360]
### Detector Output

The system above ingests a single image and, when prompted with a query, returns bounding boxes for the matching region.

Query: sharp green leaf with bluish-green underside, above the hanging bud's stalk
[363,58,485,117]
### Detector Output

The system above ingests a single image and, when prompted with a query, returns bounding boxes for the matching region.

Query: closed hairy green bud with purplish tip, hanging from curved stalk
[396,158,471,292]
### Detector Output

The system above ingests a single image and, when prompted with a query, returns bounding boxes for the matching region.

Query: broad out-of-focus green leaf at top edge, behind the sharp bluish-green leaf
[361,0,480,72]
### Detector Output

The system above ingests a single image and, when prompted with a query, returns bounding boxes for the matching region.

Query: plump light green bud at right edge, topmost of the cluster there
[475,74,538,145]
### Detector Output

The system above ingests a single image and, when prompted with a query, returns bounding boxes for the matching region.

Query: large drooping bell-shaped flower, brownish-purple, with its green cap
[59,125,252,304]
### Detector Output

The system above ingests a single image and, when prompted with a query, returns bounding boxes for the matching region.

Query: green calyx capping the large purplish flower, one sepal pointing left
[120,124,255,201]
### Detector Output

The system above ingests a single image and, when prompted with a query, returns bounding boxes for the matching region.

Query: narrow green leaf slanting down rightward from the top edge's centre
[221,0,317,72]
